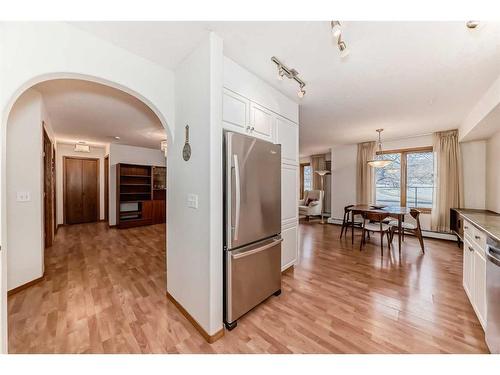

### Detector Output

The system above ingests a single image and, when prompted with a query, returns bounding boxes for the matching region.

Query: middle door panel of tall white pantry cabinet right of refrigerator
[281,164,299,223]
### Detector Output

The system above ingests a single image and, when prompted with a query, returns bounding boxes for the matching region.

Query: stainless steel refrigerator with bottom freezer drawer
[224,132,282,330]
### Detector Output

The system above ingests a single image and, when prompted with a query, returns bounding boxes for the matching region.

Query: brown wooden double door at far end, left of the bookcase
[64,157,99,224]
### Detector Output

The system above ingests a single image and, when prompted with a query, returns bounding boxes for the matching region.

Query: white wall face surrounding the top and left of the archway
[0,22,175,353]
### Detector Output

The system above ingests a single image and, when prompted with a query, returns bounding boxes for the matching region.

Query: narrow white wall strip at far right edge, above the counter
[486,131,500,213]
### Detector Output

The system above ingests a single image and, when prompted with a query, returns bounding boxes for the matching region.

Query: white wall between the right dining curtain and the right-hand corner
[460,141,486,209]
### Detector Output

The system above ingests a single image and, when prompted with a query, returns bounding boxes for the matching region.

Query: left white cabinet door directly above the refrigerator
[222,89,250,132]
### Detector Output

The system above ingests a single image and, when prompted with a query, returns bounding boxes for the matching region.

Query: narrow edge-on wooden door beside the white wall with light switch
[42,128,54,247]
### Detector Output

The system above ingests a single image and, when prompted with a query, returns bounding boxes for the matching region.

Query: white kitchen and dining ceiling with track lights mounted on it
[73,21,500,155]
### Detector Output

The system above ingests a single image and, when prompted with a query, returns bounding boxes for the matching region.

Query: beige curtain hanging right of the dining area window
[431,130,463,232]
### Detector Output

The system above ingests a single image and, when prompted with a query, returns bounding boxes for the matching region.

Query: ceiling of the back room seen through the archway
[34,79,166,149]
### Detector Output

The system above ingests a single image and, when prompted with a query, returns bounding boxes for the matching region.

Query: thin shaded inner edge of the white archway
[1,74,171,356]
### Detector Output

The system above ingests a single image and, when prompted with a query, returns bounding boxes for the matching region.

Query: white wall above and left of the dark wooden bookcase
[108,143,165,225]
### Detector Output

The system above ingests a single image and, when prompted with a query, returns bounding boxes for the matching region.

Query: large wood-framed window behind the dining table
[375,148,434,211]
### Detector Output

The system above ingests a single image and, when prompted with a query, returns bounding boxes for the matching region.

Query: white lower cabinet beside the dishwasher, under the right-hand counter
[463,221,487,329]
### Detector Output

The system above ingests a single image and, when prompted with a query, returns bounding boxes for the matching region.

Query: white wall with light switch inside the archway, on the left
[6,90,53,290]
